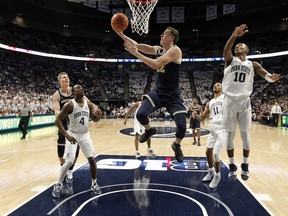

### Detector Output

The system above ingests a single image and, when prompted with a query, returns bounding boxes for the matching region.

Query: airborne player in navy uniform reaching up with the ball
[116,27,187,162]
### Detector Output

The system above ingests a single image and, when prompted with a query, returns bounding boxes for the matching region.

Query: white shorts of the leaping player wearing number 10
[222,95,252,132]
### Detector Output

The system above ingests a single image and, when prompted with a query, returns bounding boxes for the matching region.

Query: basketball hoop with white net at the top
[126,0,159,35]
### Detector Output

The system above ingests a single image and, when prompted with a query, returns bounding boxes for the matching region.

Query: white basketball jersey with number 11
[209,94,224,125]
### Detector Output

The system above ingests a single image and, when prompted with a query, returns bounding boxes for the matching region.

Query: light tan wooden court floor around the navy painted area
[0,119,288,216]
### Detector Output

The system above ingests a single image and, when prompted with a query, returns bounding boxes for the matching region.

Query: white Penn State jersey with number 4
[68,99,90,133]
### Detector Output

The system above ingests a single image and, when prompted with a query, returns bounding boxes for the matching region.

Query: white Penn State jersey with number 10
[222,57,254,100]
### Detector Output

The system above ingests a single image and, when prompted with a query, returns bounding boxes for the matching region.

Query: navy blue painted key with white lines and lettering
[10,155,270,216]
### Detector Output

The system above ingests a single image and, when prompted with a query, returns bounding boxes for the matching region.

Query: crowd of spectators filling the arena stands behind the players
[0,21,288,126]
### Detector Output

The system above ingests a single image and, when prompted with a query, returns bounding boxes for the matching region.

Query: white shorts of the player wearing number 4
[63,131,94,159]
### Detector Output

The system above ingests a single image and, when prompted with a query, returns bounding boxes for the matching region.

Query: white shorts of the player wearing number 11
[206,125,227,150]
